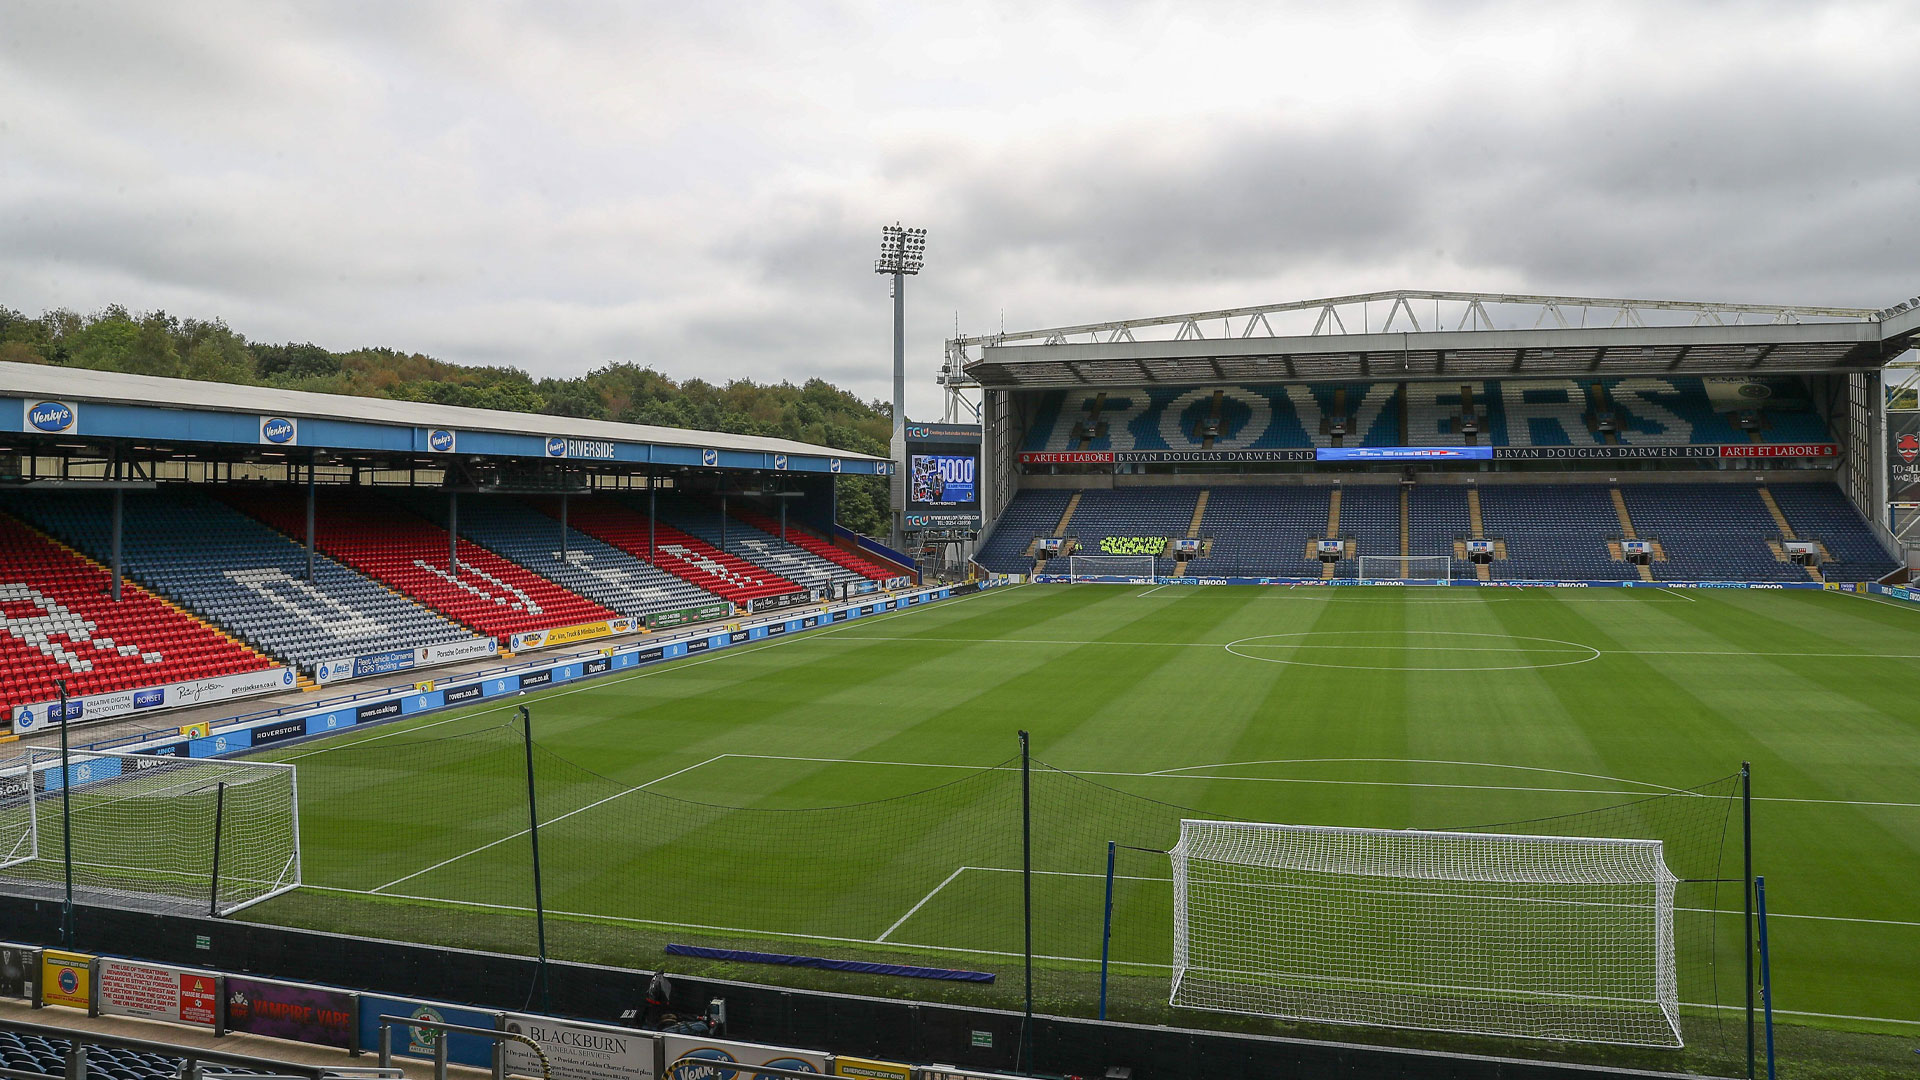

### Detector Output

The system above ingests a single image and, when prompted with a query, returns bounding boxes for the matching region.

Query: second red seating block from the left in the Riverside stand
[221,490,614,638]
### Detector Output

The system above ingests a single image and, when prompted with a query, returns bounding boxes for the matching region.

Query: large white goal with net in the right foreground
[1173,821,1682,1047]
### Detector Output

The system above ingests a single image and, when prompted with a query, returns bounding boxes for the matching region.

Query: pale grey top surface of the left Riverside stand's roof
[0,363,885,461]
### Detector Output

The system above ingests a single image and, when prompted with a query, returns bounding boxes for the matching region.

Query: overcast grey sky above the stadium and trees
[0,0,1920,417]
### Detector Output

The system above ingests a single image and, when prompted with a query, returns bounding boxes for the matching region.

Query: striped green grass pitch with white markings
[246,586,1920,1068]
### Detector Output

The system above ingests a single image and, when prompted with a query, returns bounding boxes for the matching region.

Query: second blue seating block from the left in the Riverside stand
[409,498,718,619]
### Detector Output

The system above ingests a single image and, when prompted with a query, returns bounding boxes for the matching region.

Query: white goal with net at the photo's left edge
[0,748,300,915]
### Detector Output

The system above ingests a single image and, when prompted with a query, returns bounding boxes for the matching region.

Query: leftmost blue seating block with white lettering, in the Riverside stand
[0,492,472,665]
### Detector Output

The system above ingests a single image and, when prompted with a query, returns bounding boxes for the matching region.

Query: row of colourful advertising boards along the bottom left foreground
[0,942,1006,1080]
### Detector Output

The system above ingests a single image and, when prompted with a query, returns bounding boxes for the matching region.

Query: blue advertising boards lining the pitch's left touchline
[37,577,1008,757]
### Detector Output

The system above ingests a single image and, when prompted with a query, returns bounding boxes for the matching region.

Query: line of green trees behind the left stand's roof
[0,306,893,536]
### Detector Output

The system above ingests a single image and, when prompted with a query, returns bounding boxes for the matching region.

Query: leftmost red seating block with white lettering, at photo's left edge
[0,517,273,715]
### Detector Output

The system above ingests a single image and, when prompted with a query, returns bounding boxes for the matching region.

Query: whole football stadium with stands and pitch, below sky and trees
[0,292,1920,1076]
